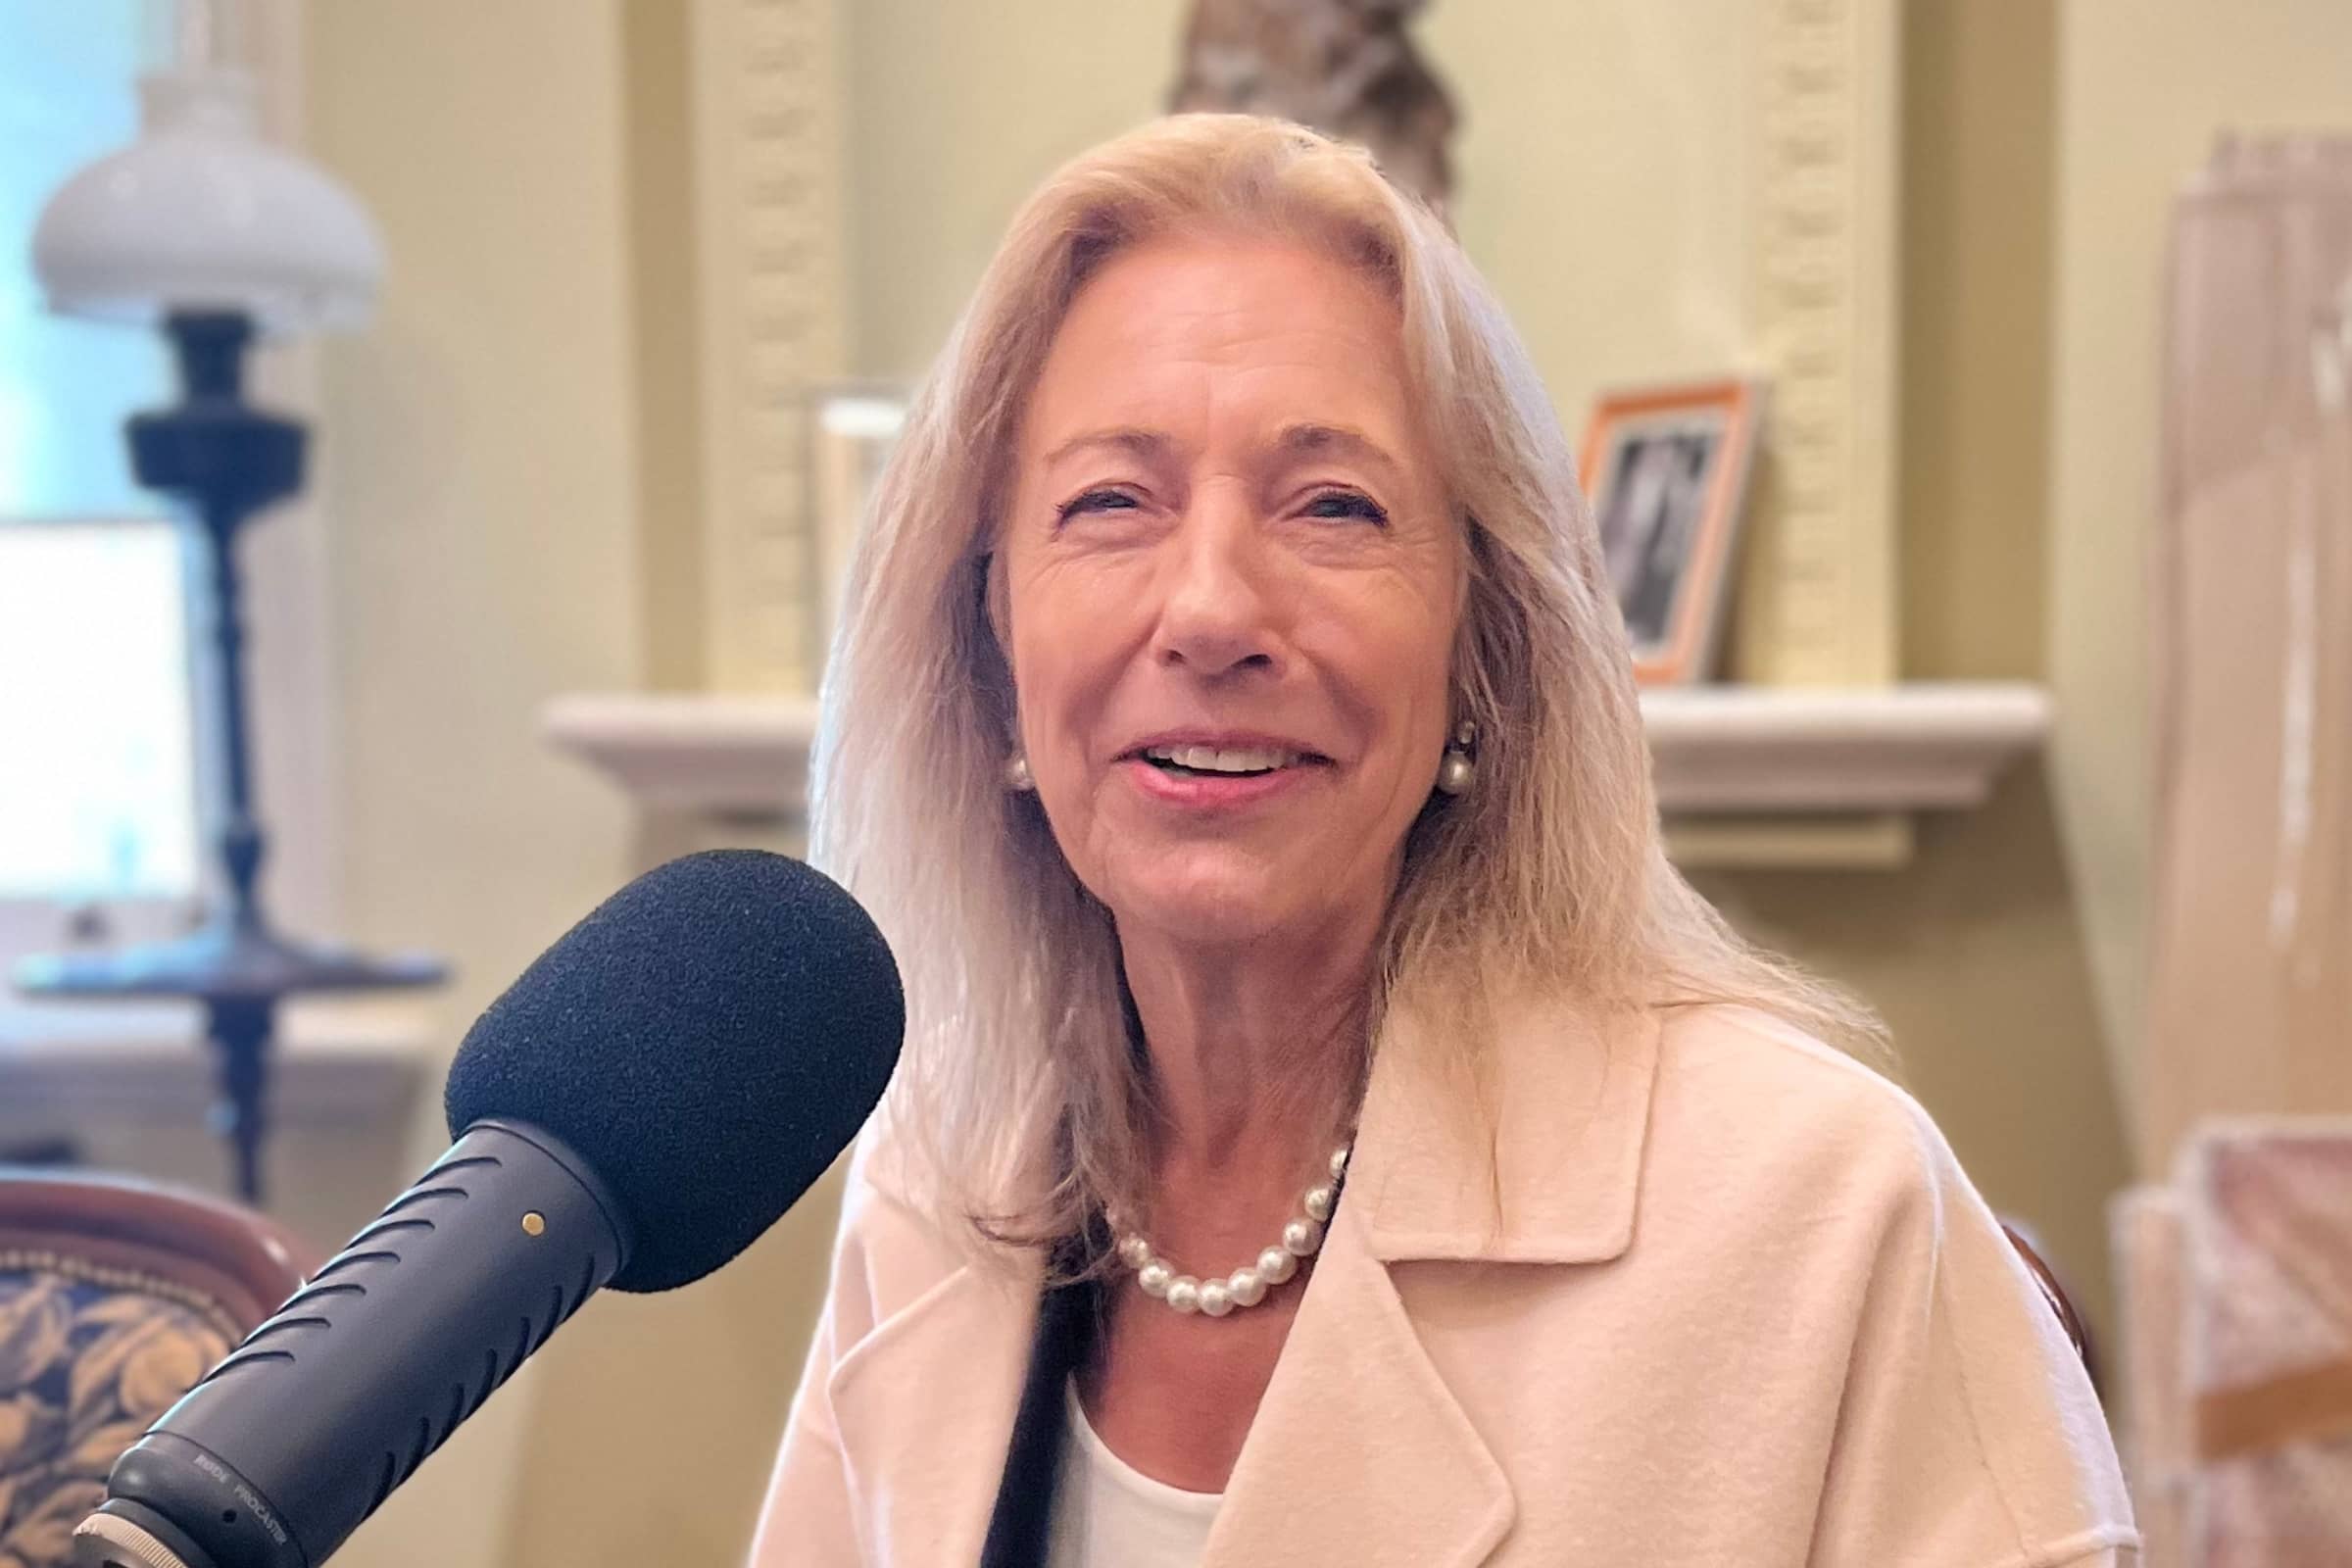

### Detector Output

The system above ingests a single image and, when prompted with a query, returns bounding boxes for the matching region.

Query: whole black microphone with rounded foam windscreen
[73,849,906,1568]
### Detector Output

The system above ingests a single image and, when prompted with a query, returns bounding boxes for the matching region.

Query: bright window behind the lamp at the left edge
[0,0,200,1015]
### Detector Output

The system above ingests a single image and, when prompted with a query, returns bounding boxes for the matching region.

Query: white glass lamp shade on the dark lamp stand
[33,69,383,334]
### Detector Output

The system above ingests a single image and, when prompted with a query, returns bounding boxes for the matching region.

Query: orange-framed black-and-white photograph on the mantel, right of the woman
[1578,378,1764,686]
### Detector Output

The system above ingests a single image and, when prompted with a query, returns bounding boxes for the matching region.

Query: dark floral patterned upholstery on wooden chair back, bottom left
[0,1253,230,1568]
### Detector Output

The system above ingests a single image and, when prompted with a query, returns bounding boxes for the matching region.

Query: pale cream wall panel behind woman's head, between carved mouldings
[845,0,1757,418]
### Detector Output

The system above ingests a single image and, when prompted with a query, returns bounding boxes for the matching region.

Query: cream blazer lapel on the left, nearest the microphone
[830,1265,1040,1568]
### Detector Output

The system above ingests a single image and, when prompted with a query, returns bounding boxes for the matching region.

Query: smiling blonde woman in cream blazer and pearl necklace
[755,116,2133,1568]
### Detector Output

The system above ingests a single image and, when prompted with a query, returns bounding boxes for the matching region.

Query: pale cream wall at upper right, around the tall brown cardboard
[2048,0,2352,1165]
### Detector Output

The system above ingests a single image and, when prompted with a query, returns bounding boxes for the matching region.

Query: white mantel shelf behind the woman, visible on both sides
[543,684,2051,820]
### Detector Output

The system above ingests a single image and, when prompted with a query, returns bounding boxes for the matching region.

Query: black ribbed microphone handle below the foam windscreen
[75,1119,628,1568]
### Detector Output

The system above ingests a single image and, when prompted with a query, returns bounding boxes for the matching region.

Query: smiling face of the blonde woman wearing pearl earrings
[998,226,1465,945]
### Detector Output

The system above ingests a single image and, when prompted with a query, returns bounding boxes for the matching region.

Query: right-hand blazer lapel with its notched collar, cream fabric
[1204,1004,1658,1568]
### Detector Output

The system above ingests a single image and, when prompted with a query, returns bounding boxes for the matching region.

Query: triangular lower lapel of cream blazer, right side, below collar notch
[1201,1203,1515,1568]
